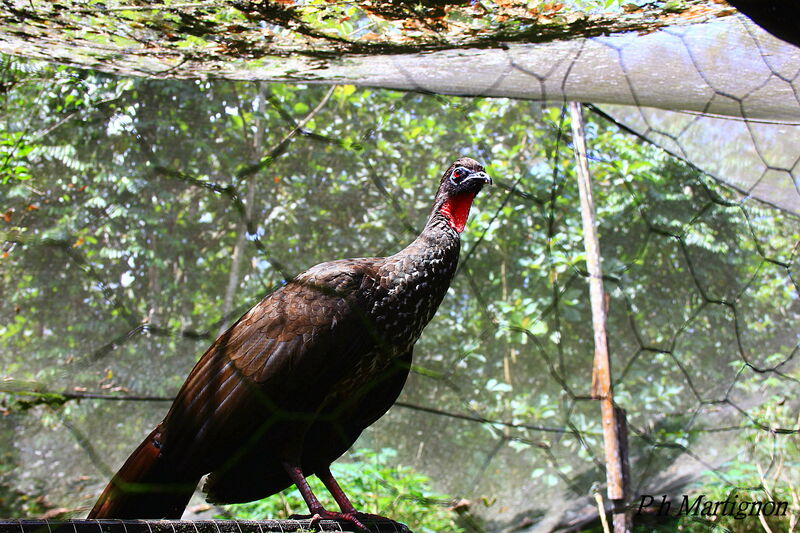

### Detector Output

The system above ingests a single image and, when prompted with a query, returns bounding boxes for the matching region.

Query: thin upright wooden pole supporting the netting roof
[569,102,631,533]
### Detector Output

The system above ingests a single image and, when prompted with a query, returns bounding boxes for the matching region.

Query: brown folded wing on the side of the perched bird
[162,259,382,477]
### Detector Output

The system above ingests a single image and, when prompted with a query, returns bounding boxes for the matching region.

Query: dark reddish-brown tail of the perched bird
[87,426,198,519]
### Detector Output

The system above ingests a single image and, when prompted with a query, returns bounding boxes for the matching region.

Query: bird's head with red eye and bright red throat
[432,157,492,233]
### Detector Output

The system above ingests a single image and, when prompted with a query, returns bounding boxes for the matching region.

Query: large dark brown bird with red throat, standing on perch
[87,157,492,529]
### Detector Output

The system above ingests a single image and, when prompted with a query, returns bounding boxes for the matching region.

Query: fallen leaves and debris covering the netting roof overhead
[0,0,734,79]
